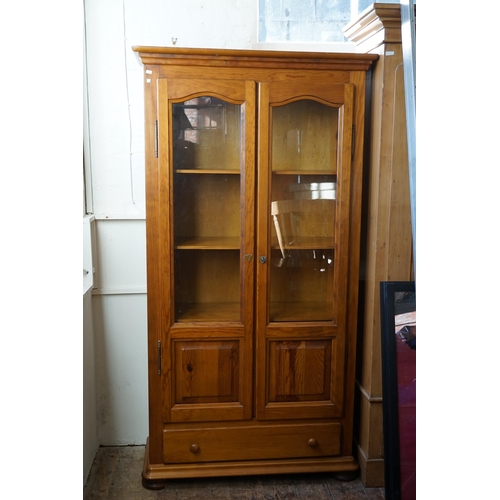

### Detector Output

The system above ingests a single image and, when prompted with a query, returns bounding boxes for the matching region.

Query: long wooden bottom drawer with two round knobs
[163,422,341,463]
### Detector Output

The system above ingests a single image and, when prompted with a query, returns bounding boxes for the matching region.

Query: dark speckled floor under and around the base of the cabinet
[83,446,384,500]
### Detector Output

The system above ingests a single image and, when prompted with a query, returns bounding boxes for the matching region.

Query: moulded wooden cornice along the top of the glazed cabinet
[132,46,378,70]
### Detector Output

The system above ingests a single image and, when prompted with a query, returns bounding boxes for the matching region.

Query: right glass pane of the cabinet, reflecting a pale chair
[269,99,339,321]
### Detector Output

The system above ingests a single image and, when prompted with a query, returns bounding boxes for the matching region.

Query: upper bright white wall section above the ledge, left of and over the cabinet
[85,0,257,218]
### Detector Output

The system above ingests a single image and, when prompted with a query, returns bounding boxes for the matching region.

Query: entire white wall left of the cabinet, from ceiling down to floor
[84,0,258,460]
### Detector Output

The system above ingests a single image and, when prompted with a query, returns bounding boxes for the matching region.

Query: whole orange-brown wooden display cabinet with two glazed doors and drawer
[134,47,377,488]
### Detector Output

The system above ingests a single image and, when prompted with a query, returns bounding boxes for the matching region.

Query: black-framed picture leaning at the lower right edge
[380,281,416,500]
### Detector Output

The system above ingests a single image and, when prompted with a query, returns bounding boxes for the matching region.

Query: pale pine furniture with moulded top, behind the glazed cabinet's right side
[344,3,414,487]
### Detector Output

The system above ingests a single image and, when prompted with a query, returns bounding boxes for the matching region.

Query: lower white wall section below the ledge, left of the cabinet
[93,219,148,445]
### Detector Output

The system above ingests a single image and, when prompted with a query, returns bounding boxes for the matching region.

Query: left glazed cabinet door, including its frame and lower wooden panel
[158,78,255,422]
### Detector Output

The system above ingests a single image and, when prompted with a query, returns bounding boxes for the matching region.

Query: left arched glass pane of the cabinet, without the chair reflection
[172,96,242,322]
